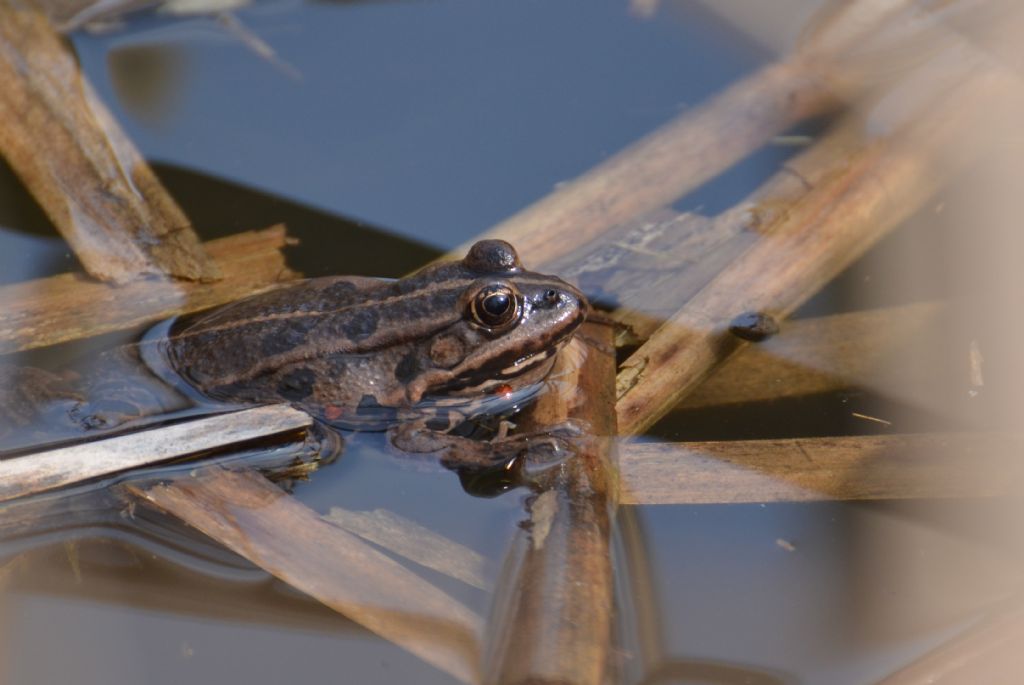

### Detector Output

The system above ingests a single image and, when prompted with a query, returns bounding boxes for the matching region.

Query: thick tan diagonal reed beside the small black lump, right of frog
[617,115,938,435]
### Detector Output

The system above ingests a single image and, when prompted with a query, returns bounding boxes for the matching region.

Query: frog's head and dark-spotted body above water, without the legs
[167,240,587,423]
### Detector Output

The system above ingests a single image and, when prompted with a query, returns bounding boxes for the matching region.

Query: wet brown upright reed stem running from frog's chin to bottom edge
[484,325,617,685]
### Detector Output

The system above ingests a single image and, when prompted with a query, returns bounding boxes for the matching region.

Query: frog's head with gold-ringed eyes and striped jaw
[406,240,589,403]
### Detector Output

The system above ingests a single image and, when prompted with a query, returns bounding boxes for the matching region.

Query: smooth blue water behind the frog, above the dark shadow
[75,0,772,249]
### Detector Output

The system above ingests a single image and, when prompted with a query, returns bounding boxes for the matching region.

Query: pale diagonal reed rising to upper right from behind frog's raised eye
[453,57,837,268]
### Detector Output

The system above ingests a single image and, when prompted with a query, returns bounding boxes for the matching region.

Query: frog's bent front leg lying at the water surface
[388,422,580,472]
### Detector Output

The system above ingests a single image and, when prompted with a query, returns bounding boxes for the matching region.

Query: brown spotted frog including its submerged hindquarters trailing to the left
[0,241,588,481]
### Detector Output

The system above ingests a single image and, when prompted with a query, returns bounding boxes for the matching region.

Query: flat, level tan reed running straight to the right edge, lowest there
[620,433,1024,505]
